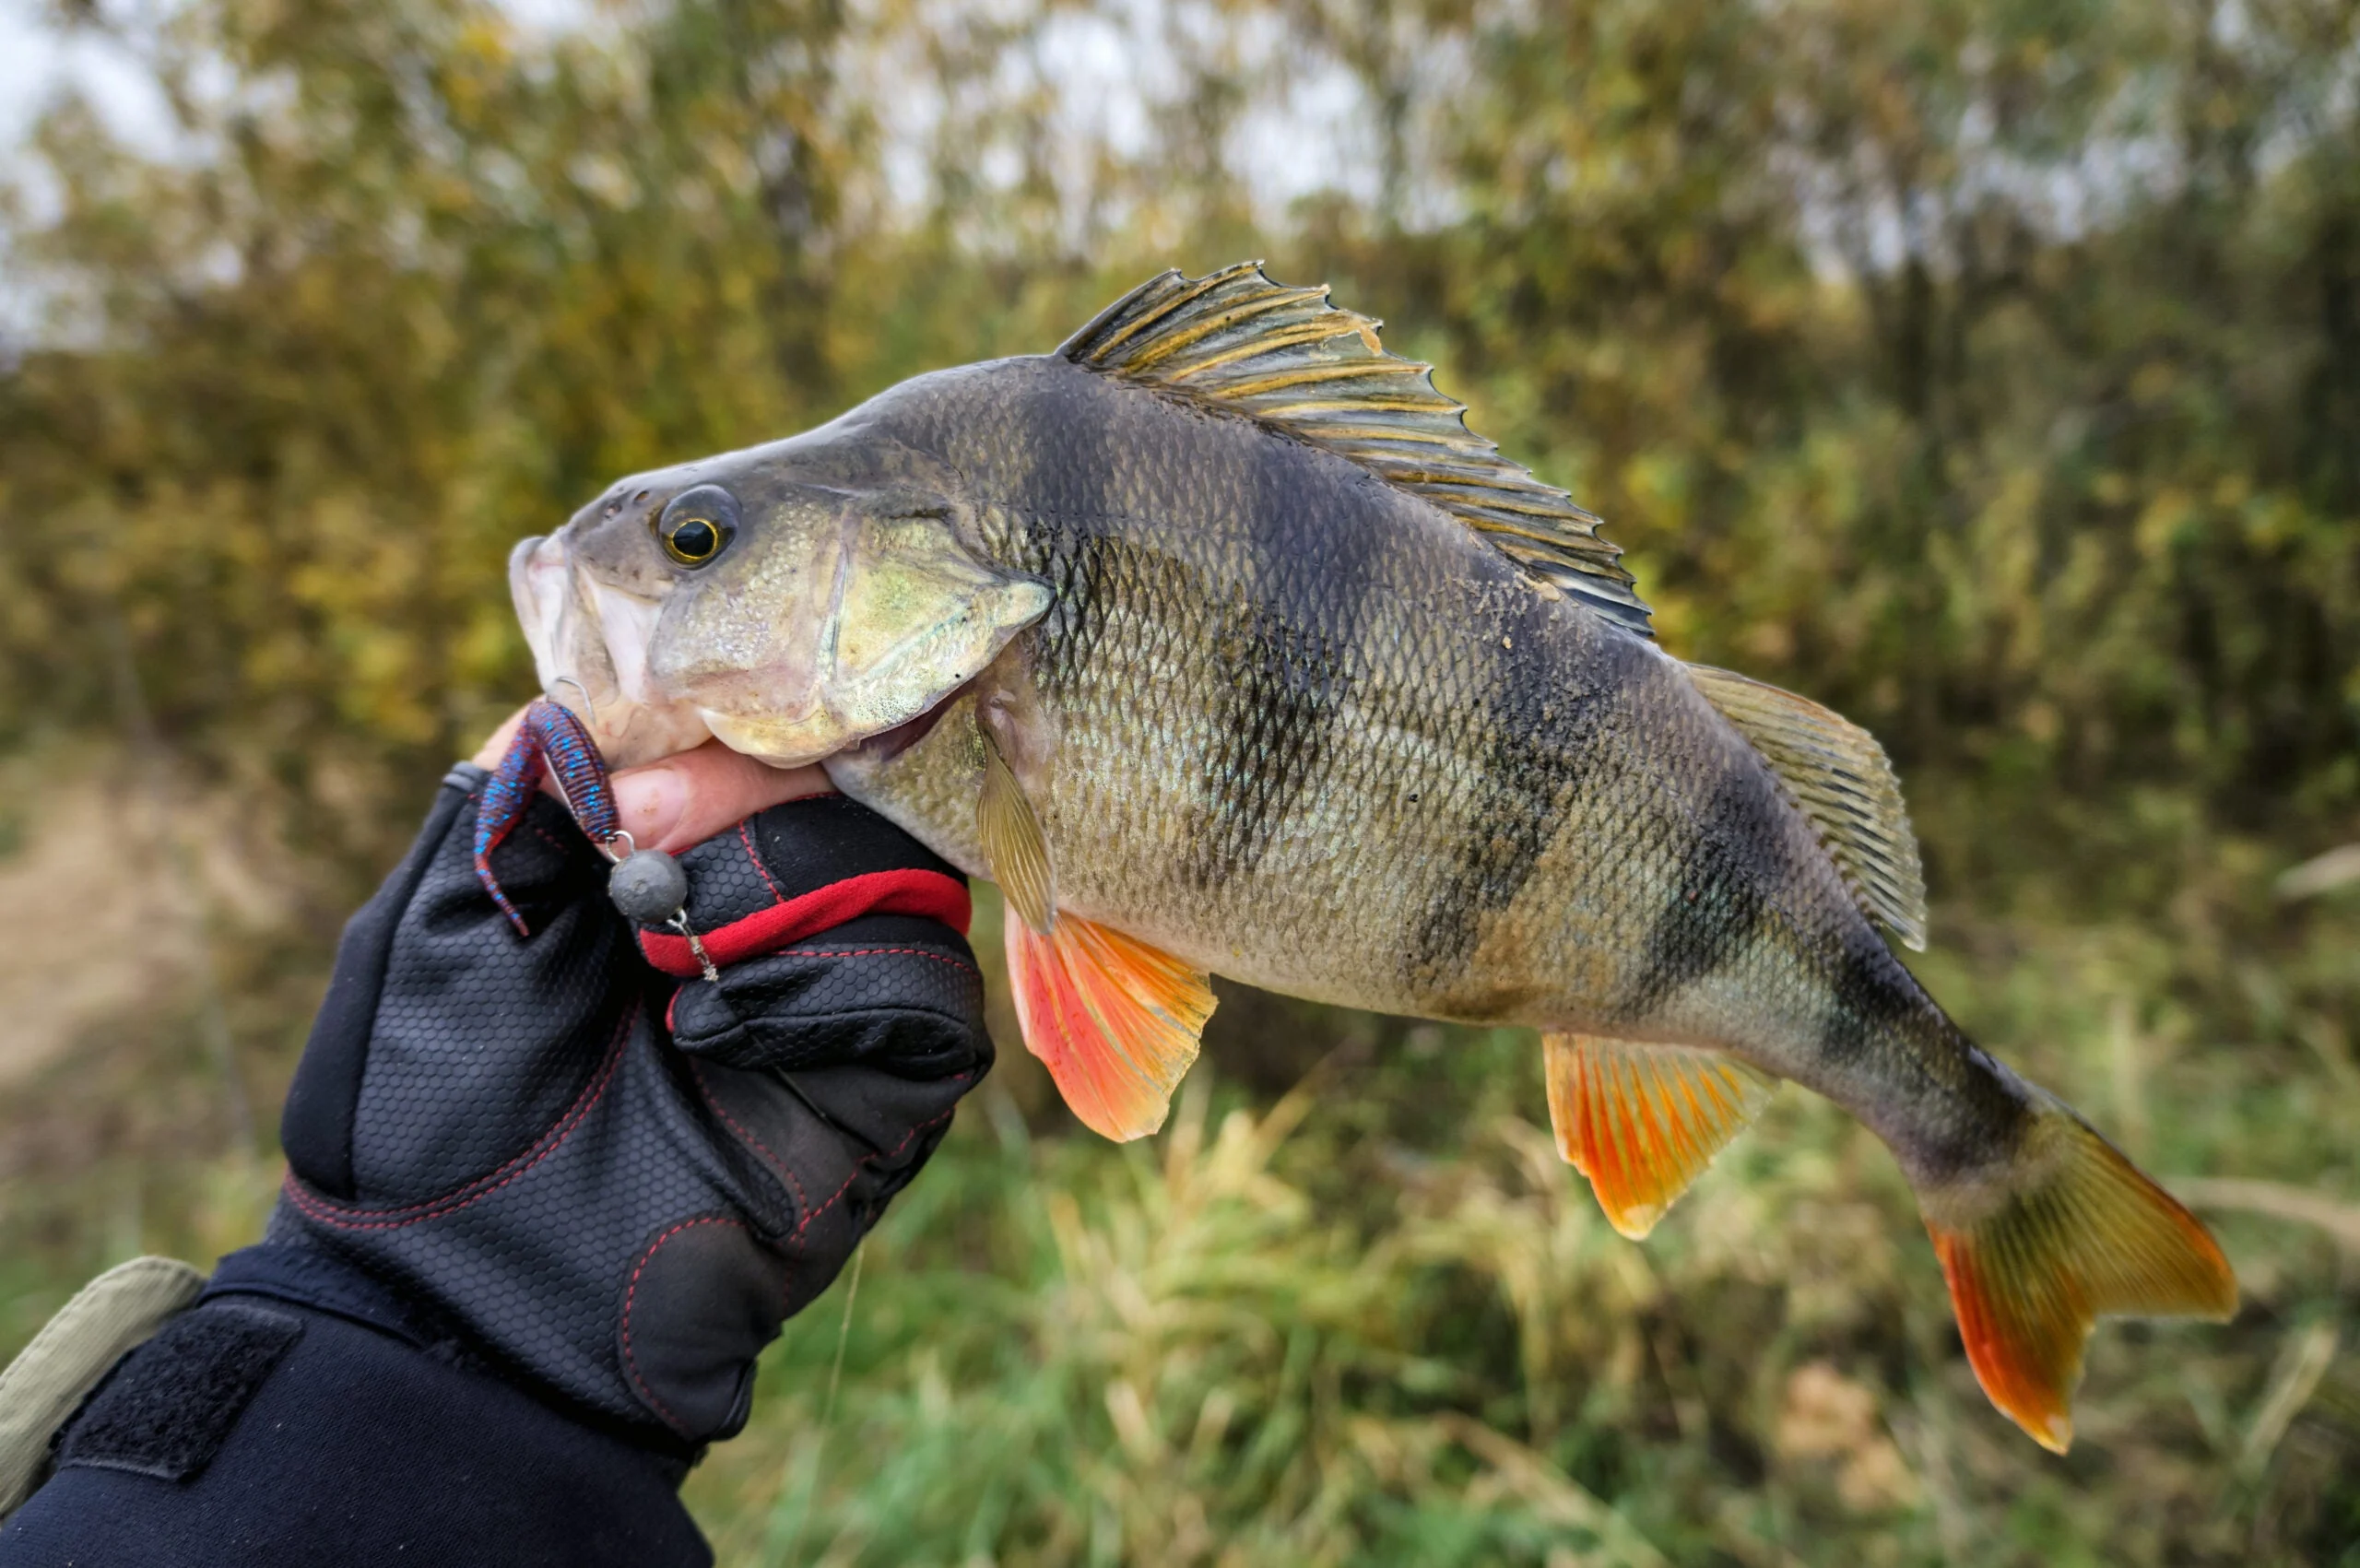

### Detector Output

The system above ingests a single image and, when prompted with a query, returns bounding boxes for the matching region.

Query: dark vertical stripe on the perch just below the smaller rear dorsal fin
[1617,760,1791,1020]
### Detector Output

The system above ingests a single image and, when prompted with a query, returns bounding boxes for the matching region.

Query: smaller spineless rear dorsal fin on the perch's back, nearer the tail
[1687,664,1926,951]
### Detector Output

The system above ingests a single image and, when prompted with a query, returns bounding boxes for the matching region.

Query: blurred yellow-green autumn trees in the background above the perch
[0,0,2360,902]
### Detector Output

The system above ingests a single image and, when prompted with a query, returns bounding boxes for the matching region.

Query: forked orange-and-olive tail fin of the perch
[1918,1091,2237,1452]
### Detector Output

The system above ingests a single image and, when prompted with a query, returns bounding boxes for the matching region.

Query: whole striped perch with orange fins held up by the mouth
[513,265,2237,1450]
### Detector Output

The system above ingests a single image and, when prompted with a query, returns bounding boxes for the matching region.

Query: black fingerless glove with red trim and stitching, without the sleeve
[249,768,991,1455]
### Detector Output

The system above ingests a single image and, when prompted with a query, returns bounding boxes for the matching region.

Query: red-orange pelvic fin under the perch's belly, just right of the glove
[1008,912,1213,1143]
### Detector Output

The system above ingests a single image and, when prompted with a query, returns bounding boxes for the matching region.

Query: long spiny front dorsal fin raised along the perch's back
[1057,262,1655,638]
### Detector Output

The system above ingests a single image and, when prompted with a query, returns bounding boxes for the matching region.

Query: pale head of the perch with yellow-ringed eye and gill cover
[510,437,1050,768]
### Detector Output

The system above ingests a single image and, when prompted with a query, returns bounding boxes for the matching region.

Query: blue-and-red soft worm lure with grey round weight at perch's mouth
[475,697,720,980]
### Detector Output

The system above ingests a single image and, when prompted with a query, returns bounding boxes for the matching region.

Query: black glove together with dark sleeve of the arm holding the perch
[0,737,991,1568]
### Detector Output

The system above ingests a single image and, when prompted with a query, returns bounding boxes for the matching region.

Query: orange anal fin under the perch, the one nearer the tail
[1541,1034,1777,1240]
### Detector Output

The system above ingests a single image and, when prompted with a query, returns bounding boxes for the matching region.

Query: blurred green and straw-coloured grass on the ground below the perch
[0,812,2360,1568]
